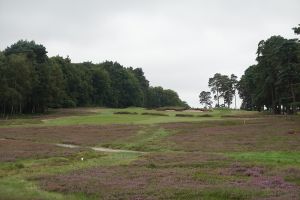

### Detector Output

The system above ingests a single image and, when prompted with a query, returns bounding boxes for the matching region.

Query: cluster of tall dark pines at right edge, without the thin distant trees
[238,27,300,114]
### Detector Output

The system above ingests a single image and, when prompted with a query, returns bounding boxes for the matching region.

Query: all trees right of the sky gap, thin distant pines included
[199,25,300,114]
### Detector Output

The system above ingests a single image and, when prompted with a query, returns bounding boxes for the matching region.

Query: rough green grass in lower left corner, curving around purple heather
[0,151,140,200]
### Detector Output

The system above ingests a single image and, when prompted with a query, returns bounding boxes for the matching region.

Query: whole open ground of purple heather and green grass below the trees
[0,108,300,200]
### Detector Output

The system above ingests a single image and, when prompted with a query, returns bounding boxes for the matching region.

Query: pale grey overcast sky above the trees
[0,0,300,107]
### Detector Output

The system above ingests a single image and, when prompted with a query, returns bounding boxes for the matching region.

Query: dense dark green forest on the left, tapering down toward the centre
[0,40,188,116]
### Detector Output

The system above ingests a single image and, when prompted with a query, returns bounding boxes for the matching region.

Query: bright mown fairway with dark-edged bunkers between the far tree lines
[43,108,257,126]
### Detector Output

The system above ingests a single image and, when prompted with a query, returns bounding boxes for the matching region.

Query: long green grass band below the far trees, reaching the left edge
[0,108,256,127]
